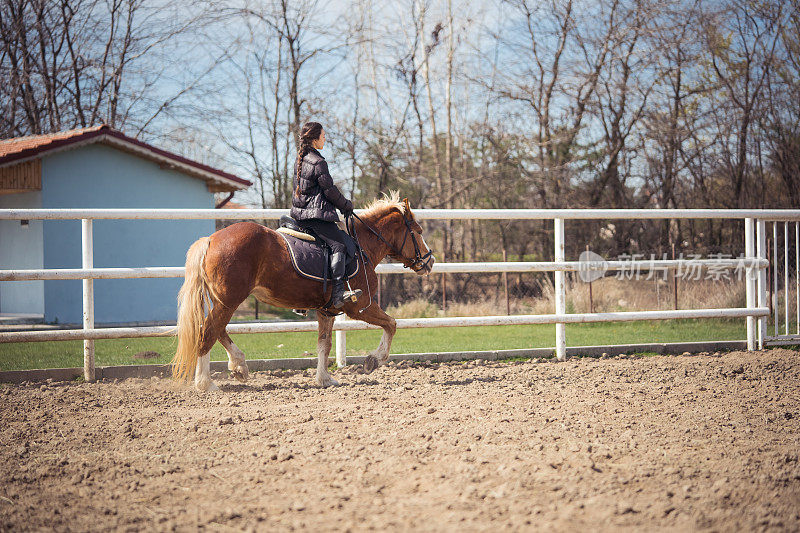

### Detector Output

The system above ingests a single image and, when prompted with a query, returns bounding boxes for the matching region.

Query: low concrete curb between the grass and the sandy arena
[0,341,747,383]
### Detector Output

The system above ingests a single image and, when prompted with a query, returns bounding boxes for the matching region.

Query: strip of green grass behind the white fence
[0,319,746,370]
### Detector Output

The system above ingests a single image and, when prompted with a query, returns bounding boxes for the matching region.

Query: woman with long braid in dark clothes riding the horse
[290,122,361,309]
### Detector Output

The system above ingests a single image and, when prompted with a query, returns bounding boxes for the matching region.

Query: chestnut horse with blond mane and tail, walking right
[172,192,434,391]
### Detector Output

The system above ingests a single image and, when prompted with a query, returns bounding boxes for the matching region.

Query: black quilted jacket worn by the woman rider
[291,148,353,222]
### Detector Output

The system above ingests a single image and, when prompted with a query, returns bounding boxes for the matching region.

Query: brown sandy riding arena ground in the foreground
[0,350,800,531]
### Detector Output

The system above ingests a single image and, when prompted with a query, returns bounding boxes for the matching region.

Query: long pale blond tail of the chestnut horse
[172,237,211,381]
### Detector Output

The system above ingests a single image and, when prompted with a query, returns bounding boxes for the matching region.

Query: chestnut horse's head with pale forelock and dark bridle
[366,192,436,275]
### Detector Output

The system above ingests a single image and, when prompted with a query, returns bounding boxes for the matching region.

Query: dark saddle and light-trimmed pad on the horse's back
[276,215,358,284]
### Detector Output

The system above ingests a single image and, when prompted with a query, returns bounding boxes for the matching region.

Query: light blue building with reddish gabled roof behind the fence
[0,126,250,324]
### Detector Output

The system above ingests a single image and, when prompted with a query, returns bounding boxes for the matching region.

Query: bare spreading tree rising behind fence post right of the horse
[484,0,619,207]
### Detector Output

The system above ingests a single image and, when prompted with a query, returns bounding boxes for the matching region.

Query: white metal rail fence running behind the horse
[0,209,800,380]
